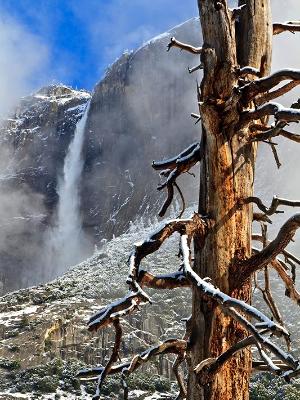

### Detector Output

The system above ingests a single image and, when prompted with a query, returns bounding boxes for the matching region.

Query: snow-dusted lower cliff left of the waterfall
[0,85,90,292]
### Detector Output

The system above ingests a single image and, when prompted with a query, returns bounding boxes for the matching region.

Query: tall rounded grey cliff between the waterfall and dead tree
[82,19,201,238]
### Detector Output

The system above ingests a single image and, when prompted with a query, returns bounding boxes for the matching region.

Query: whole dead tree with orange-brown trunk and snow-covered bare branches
[78,0,300,400]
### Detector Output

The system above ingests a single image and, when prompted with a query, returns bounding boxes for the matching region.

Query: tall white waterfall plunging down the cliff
[48,102,90,273]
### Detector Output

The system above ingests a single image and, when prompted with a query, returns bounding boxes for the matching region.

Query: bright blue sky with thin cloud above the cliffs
[0,0,197,89]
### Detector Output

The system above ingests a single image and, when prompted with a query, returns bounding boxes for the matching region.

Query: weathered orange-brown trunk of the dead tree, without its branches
[187,0,272,400]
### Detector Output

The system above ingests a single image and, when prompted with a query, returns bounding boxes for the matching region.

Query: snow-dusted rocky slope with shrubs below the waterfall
[0,211,190,399]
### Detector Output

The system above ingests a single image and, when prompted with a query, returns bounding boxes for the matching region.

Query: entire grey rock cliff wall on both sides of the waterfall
[0,19,200,292]
